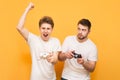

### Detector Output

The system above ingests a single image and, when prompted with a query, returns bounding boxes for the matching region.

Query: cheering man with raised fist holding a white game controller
[17,3,61,80]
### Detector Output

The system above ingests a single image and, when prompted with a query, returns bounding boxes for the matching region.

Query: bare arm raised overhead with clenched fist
[17,3,34,40]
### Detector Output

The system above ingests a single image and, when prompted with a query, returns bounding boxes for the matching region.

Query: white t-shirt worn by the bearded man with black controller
[62,36,97,80]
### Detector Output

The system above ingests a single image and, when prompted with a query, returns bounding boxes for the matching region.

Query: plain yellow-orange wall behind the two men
[0,0,120,80]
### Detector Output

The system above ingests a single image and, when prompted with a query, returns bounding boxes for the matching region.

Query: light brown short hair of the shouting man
[39,16,54,28]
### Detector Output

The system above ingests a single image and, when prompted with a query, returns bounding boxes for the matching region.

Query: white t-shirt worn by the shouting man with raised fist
[28,33,61,80]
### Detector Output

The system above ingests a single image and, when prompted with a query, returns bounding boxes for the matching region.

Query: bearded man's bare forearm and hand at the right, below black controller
[77,58,96,72]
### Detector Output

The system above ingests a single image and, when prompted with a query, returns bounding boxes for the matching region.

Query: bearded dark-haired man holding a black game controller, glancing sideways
[58,19,97,80]
